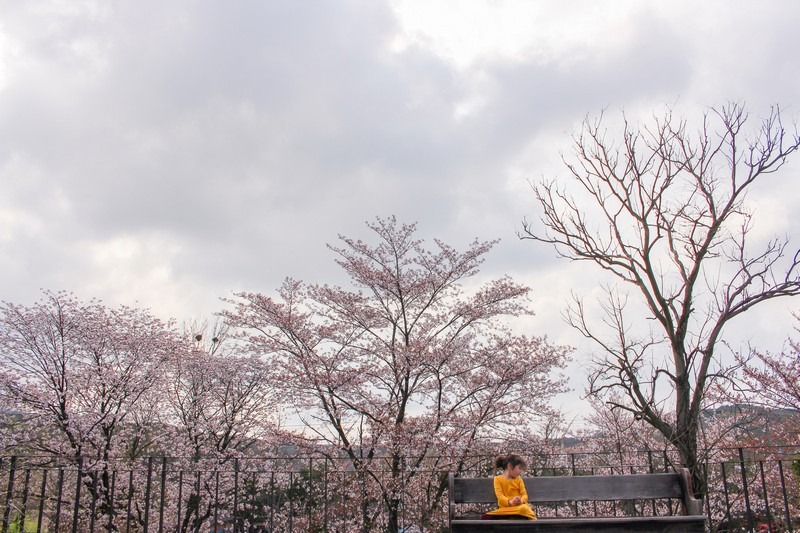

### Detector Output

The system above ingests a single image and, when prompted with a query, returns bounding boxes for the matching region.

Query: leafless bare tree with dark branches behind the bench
[520,103,800,493]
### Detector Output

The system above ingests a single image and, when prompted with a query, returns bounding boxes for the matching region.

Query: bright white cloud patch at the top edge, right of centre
[393,0,647,69]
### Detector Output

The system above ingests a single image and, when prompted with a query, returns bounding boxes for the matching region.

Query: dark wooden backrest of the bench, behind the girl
[450,469,700,514]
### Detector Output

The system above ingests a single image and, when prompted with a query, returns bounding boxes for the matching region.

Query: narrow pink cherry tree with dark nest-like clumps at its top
[161,322,278,531]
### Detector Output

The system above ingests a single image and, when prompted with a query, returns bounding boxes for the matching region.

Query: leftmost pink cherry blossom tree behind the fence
[0,291,181,520]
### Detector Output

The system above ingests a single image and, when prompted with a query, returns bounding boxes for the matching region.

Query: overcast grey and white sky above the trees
[0,0,800,418]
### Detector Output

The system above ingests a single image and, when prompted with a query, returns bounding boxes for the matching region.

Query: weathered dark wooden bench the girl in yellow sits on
[449,468,706,533]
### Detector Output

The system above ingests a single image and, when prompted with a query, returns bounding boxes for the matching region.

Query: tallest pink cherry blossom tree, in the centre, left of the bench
[224,217,568,531]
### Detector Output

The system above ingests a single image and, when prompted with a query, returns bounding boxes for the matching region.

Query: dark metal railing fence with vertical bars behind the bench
[0,447,800,533]
